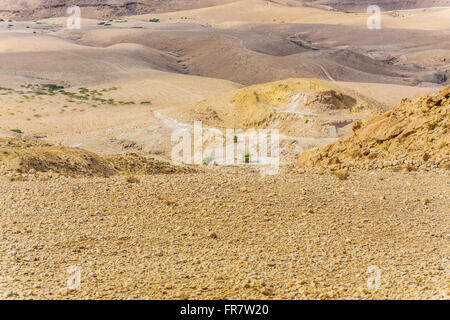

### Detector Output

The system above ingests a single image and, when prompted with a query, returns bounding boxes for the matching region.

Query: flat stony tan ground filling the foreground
[0,168,450,299]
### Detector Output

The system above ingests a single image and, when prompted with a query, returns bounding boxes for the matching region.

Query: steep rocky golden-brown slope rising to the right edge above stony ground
[298,86,450,170]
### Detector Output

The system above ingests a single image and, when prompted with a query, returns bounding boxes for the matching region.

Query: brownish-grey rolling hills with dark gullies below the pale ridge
[72,23,450,85]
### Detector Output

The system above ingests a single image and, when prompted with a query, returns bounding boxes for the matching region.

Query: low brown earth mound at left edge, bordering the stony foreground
[0,139,189,178]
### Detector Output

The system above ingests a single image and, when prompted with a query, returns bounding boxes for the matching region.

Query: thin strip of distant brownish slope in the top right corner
[299,0,450,12]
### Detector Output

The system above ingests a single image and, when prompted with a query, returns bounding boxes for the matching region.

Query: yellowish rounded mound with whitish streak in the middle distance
[174,78,386,128]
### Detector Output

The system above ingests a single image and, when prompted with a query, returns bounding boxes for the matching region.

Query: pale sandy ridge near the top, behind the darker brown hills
[130,0,450,30]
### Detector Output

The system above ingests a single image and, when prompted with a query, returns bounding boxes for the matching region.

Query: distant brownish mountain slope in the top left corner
[0,0,239,20]
